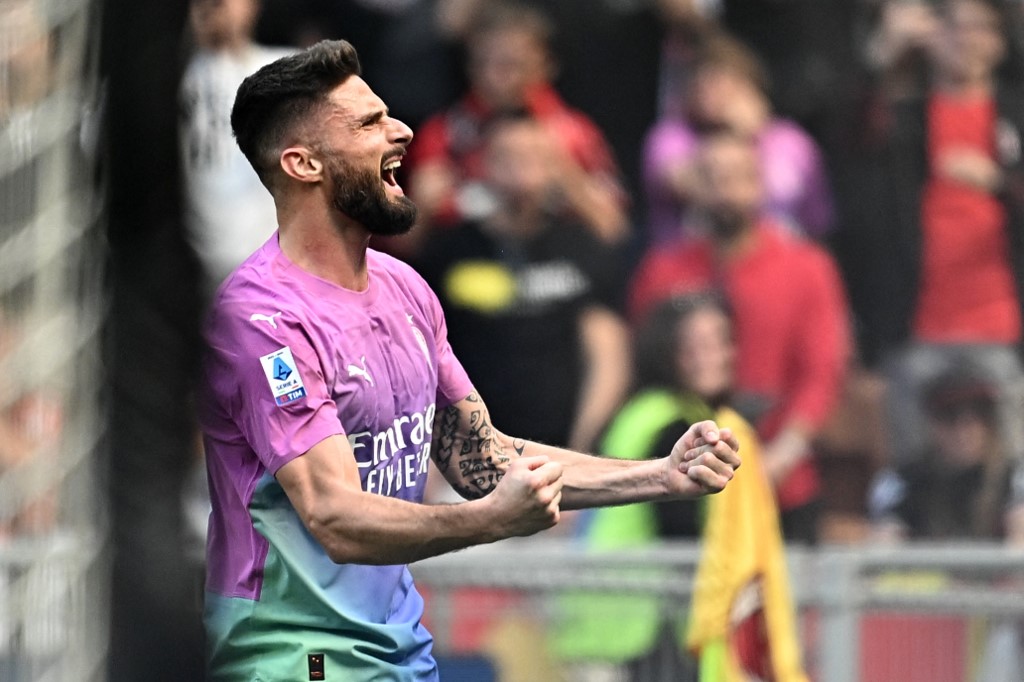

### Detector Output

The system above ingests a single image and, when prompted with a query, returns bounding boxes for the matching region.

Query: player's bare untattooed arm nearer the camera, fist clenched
[276,435,562,564]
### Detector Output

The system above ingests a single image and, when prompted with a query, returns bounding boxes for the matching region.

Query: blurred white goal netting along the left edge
[0,0,106,682]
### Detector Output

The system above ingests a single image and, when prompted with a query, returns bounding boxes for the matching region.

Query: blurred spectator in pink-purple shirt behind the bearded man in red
[644,35,833,244]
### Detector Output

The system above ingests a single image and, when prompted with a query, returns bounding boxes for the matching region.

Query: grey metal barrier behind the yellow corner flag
[413,539,1024,682]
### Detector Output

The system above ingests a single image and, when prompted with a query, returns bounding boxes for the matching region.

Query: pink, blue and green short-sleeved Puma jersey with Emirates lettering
[201,235,472,681]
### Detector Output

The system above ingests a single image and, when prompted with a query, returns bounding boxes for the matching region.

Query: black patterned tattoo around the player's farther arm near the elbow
[431,391,525,499]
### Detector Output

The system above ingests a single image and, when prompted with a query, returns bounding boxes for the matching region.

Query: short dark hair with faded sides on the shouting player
[231,40,361,186]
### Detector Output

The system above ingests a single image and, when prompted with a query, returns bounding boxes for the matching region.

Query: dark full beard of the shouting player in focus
[326,151,416,237]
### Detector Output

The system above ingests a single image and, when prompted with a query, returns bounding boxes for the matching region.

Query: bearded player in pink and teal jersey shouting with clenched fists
[201,41,739,682]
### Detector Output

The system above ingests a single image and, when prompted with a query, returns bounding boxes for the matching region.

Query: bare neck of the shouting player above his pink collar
[278,193,370,291]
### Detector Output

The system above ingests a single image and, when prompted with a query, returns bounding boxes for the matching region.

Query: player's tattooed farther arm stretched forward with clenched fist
[431,391,739,510]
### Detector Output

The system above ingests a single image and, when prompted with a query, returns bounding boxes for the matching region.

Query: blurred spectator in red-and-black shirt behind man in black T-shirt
[410,4,629,242]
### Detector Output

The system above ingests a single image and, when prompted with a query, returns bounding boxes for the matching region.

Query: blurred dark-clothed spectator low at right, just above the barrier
[869,363,1024,543]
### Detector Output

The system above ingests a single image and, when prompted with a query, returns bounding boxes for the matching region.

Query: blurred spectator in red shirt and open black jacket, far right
[839,0,1024,459]
